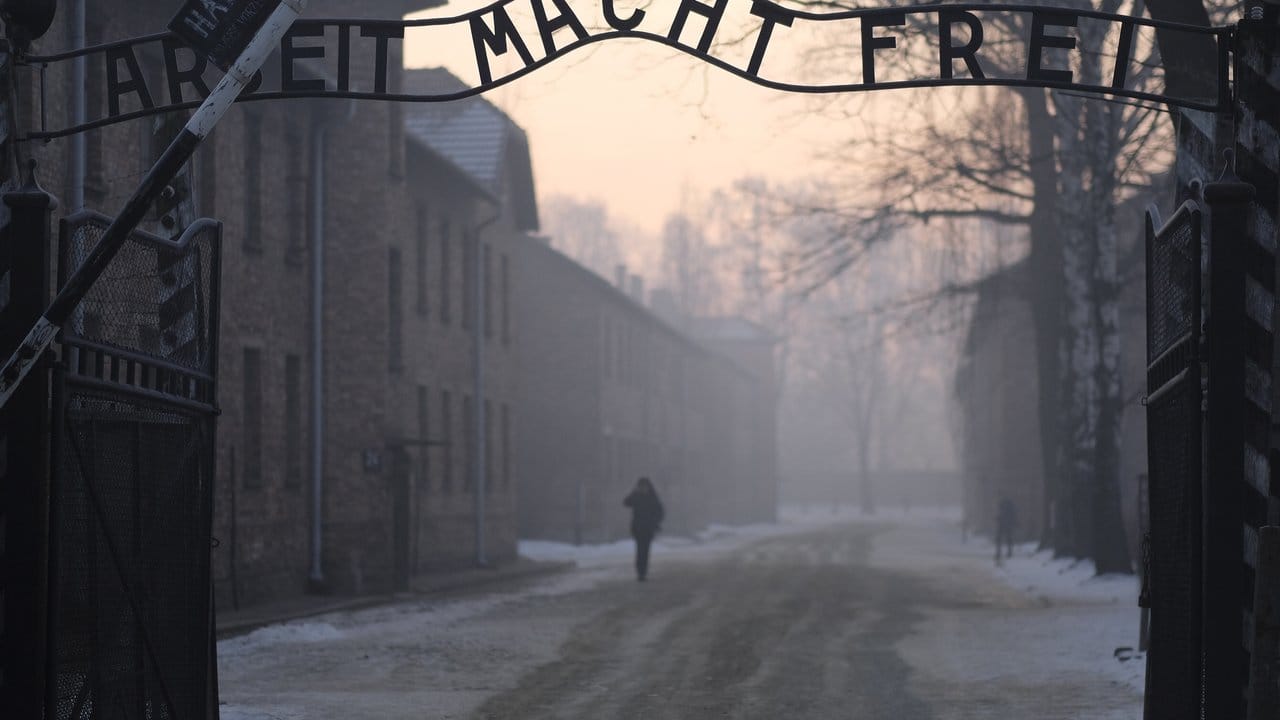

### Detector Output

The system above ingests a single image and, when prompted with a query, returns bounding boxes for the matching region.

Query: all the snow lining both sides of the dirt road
[218,507,1144,720]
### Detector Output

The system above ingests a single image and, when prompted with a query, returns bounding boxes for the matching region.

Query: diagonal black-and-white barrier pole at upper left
[0,0,306,406]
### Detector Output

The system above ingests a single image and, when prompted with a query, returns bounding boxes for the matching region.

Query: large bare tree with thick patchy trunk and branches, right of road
[742,0,1187,571]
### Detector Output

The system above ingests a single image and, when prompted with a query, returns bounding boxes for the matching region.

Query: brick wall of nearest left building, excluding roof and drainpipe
[23,0,520,607]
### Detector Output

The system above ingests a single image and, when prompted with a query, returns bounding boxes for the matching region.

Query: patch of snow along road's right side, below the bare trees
[824,502,1146,720]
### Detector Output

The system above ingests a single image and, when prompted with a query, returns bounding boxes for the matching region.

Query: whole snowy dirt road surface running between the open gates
[219,507,1142,720]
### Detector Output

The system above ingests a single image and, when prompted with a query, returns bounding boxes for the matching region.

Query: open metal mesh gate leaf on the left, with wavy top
[46,213,220,720]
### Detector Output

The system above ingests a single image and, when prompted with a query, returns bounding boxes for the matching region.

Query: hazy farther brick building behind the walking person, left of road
[516,242,777,542]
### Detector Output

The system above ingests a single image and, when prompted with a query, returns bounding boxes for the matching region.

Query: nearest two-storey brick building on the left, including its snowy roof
[23,0,524,607]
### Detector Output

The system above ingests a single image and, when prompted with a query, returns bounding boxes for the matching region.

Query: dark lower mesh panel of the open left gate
[54,391,211,720]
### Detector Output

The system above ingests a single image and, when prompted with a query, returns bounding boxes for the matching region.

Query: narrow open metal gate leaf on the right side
[1142,200,1203,720]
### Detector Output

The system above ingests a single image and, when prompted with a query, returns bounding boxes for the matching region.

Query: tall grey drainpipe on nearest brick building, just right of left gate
[307,101,356,592]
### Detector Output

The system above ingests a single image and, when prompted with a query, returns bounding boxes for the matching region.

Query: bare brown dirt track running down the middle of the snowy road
[479,520,931,720]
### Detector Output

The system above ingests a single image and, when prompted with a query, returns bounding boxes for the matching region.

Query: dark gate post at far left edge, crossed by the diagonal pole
[0,163,58,717]
